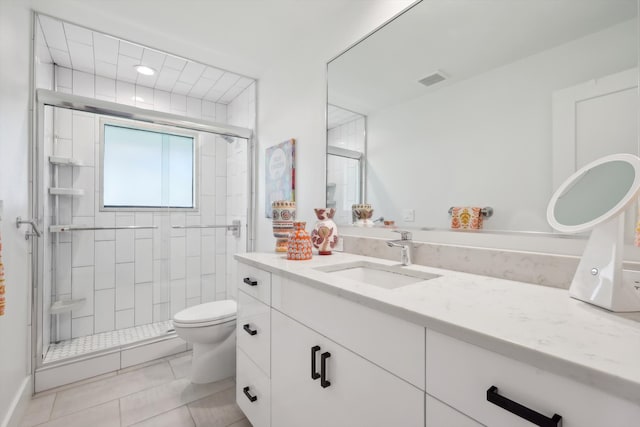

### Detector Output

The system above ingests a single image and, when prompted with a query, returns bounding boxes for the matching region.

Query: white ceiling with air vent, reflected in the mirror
[329,0,638,114]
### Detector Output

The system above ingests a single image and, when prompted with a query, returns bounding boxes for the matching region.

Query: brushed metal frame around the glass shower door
[29,88,256,374]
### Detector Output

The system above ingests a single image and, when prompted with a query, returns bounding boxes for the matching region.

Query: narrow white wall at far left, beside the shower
[0,0,31,426]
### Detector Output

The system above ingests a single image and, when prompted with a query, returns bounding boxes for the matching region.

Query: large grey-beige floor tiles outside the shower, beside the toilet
[21,352,251,427]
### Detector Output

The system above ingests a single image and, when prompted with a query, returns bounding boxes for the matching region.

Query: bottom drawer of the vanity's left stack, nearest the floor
[236,349,271,427]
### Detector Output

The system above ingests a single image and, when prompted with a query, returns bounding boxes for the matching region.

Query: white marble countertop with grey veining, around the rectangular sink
[235,252,640,405]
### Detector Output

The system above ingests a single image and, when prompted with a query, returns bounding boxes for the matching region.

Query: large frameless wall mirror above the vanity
[327,0,638,232]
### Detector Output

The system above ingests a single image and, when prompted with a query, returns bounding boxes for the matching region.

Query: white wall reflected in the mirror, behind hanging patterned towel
[367,20,637,231]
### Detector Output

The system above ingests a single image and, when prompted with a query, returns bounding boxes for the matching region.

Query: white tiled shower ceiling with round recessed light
[36,15,254,104]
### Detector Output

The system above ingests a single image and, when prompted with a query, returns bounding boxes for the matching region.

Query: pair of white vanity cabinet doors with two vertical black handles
[271,310,424,427]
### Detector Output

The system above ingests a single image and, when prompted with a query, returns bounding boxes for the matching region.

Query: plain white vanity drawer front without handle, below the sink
[272,274,425,390]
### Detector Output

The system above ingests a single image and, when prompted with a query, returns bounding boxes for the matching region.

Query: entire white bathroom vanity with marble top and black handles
[235,253,640,427]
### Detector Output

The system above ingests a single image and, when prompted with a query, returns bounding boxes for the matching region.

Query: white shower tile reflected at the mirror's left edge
[327,117,365,224]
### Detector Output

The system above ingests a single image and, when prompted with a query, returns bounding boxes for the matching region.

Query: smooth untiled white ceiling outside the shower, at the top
[32,0,414,78]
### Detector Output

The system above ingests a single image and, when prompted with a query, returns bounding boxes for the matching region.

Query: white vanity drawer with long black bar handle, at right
[426,329,640,427]
